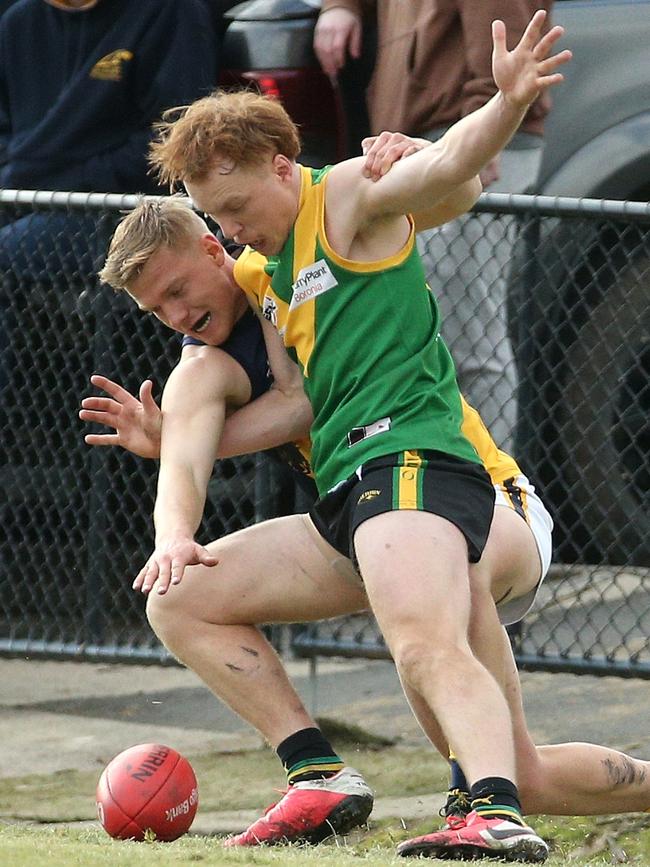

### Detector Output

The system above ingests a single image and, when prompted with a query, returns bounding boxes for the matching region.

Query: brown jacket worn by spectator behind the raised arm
[322,0,552,135]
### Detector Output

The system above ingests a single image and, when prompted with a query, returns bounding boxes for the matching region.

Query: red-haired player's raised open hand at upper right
[492,9,571,108]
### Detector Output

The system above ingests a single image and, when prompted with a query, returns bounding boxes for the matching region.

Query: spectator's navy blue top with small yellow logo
[0,0,217,193]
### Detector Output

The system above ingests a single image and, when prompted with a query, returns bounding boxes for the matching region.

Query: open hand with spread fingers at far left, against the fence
[79,374,162,458]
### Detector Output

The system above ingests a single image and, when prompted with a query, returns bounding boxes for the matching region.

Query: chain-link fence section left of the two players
[0,191,292,661]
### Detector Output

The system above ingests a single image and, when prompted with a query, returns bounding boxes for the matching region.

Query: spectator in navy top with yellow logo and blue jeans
[0,0,218,389]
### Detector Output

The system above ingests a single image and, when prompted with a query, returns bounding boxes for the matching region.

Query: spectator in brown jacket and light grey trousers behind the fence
[314,0,552,451]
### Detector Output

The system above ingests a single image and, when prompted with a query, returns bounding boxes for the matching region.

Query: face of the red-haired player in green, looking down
[185,156,300,256]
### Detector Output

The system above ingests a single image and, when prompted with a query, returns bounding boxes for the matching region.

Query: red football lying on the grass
[97,744,199,841]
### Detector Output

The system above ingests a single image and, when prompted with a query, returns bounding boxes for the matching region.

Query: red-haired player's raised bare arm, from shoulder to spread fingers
[326,10,571,260]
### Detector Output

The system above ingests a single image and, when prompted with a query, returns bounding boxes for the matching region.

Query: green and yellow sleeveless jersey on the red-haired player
[235,166,479,493]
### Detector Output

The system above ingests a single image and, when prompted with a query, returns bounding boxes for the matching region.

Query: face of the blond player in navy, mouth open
[128,235,247,346]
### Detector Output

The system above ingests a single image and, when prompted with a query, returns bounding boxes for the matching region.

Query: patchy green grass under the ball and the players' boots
[0,744,650,867]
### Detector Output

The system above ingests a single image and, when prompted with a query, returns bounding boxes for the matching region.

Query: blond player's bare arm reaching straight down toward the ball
[133,347,250,594]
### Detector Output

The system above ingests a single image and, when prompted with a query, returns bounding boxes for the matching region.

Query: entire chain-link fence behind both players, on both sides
[0,191,650,677]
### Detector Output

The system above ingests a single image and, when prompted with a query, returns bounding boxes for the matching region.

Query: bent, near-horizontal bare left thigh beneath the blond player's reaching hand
[152,515,367,624]
